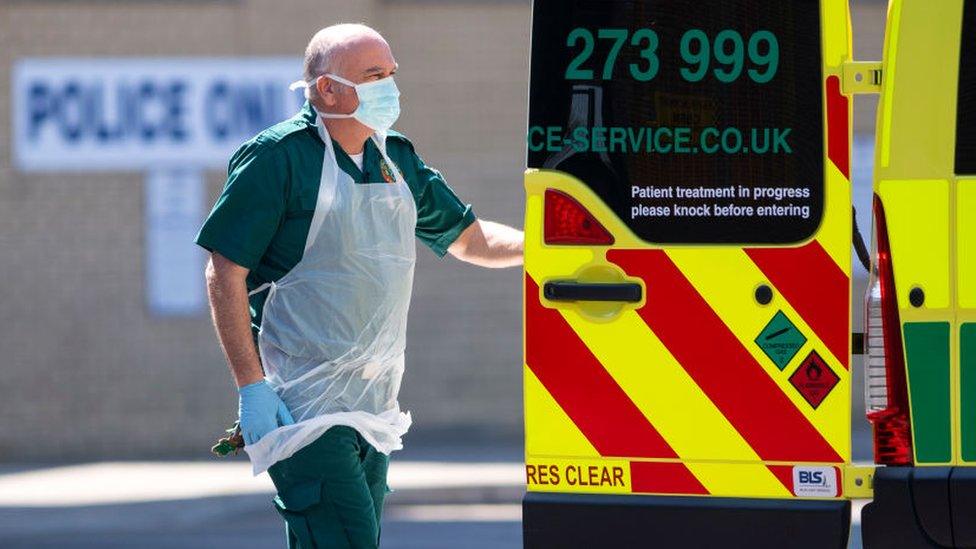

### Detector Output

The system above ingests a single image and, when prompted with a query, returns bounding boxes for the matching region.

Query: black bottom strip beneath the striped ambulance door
[522,492,852,549]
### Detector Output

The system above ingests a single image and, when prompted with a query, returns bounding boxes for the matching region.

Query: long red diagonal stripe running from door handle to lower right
[607,250,842,462]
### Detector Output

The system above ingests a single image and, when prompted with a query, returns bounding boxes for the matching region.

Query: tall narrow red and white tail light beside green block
[864,195,912,465]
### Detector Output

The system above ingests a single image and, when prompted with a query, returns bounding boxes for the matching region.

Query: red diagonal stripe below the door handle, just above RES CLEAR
[525,274,690,458]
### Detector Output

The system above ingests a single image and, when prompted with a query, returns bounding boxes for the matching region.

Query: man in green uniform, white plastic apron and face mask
[196,25,523,548]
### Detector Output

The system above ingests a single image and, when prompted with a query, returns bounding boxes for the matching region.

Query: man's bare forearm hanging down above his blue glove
[207,253,264,387]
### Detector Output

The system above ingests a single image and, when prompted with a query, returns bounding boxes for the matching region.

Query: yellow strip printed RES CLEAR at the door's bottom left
[525,458,631,494]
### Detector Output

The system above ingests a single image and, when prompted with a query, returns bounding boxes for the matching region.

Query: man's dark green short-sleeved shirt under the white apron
[196,102,475,331]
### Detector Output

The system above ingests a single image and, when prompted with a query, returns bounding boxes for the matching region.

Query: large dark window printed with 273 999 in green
[528,0,824,243]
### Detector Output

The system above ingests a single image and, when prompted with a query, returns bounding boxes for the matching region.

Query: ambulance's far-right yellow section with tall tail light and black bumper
[861,0,976,547]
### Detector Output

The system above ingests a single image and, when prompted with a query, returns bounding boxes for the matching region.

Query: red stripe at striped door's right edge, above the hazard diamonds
[746,240,851,368]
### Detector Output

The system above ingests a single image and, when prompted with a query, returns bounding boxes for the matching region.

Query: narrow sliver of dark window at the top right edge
[956,0,976,175]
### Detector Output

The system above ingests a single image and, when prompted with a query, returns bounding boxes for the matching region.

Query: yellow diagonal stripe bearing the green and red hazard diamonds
[667,248,851,461]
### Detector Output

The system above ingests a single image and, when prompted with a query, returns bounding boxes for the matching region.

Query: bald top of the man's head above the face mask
[303,23,395,99]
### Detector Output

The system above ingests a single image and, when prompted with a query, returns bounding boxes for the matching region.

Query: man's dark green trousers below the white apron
[268,426,390,549]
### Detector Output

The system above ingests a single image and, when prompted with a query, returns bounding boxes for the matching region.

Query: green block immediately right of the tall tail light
[905,322,952,463]
